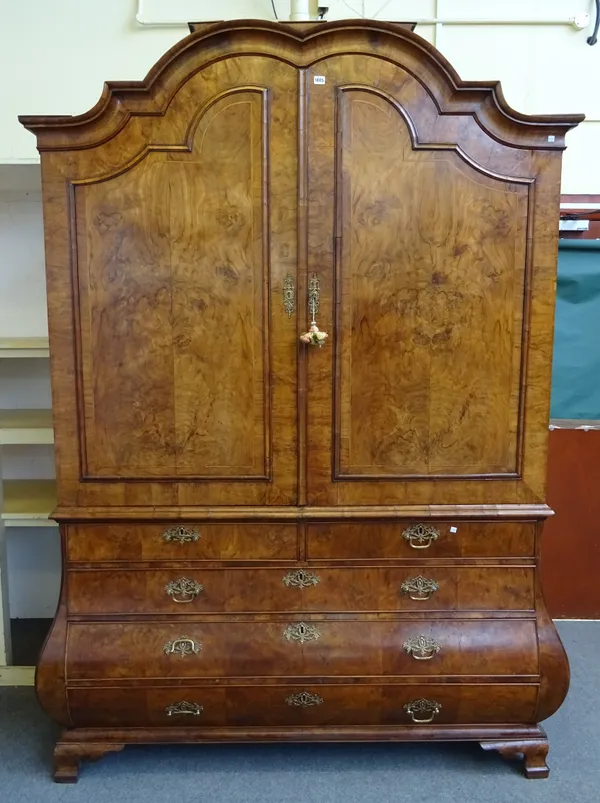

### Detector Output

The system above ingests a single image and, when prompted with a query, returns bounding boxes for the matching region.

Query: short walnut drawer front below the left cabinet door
[67,522,297,561]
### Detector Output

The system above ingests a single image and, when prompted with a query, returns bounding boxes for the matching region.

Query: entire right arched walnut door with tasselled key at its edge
[303,55,551,505]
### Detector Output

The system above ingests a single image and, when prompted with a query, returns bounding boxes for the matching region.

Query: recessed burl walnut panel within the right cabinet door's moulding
[335,88,528,479]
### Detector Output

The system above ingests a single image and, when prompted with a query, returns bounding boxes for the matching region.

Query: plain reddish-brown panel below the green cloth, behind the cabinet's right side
[541,429,600,619]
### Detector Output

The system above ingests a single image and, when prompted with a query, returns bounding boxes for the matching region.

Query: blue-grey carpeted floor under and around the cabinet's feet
[0,622,600,803]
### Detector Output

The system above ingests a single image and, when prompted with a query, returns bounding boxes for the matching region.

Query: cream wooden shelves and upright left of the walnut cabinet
[0,337,56,686]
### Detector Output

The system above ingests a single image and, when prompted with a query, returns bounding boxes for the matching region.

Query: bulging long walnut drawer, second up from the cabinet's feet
[67,619,538,680]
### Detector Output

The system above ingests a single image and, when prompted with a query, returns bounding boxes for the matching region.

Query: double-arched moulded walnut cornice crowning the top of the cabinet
[19,19,584,151]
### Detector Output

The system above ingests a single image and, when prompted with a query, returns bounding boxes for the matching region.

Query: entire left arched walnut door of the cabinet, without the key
[66,57,298,505]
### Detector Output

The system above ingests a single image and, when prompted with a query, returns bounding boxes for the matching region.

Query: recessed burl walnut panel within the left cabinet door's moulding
[75,92,270,479]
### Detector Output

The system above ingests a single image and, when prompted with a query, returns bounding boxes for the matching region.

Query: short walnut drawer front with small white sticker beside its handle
[307,521,535,560]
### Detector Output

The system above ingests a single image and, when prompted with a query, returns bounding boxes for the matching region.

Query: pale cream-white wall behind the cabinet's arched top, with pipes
[0,0,600,193]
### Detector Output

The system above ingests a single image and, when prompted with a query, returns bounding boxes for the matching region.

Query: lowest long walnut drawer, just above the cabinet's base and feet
[68,684,537,728]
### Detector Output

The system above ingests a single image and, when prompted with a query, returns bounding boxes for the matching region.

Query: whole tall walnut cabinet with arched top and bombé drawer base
[21,20,582,781]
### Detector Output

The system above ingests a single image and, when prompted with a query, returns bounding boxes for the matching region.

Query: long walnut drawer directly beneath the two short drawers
[67,565,534,615]
